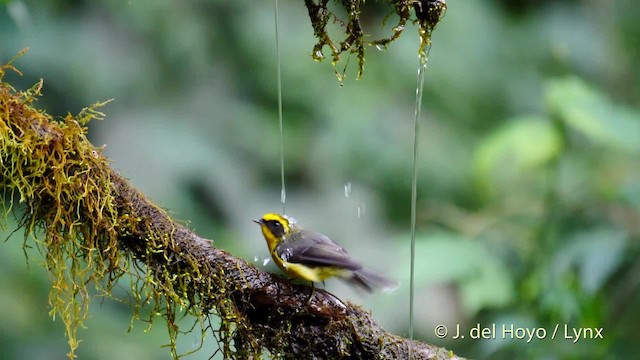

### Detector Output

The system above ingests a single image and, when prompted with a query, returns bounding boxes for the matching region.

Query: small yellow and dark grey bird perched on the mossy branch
[254,213,396,292]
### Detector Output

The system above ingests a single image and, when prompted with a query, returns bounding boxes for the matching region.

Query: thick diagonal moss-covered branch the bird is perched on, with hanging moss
[0,65,454,359]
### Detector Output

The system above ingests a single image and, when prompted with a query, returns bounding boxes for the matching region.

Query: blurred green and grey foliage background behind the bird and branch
[0,0,640,359]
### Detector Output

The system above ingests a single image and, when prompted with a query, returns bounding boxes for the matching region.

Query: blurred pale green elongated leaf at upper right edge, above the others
[545,77,640,152]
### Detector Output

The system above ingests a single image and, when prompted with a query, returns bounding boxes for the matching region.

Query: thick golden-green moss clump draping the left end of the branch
[0,59,116,356]
